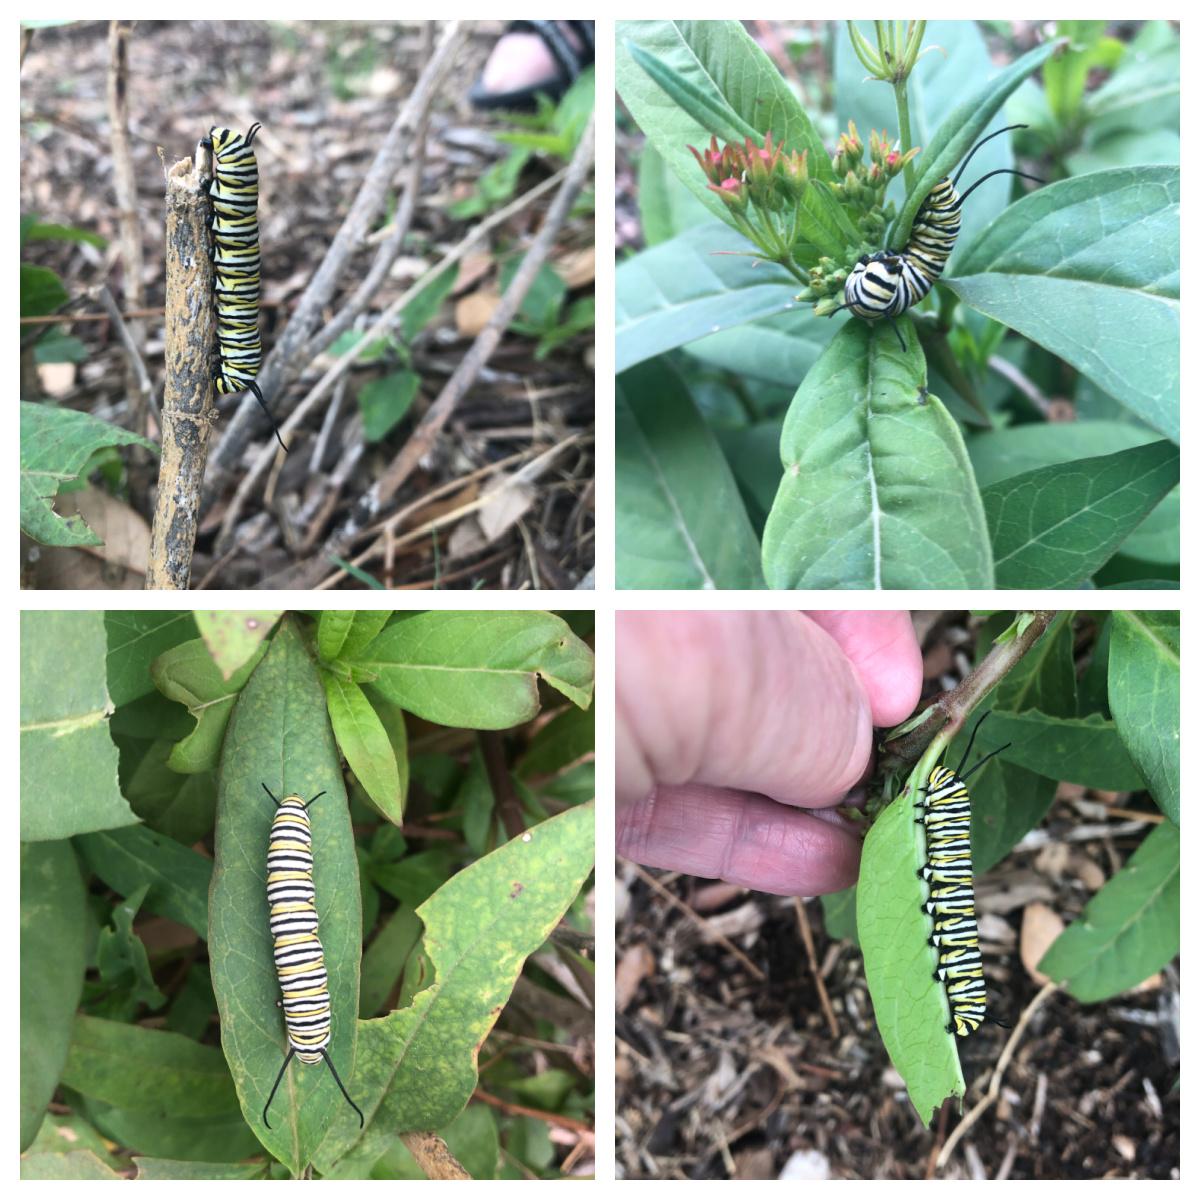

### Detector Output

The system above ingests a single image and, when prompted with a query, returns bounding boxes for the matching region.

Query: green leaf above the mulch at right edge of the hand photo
[1038,821,1180,1004]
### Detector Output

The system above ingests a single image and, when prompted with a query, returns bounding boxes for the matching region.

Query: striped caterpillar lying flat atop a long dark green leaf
[263,784,364,1129]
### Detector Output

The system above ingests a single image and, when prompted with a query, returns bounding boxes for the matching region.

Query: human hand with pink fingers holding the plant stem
[617,612,922,895]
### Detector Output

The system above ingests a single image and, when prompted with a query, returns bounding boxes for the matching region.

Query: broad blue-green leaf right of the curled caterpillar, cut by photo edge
[943,167,1180,442]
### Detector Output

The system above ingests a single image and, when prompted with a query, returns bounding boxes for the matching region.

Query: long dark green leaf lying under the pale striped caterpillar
[209,618,371,1175]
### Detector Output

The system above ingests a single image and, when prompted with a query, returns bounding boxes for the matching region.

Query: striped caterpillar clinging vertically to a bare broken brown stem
[200,121,287,451]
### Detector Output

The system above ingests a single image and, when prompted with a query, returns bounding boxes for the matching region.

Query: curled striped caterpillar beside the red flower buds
[830,125,1042,350]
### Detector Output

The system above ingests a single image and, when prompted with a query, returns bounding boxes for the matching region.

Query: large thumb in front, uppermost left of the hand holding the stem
[617,612,871,806]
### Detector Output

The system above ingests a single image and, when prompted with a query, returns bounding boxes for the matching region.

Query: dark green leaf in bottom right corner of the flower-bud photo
[983,442,1180,588]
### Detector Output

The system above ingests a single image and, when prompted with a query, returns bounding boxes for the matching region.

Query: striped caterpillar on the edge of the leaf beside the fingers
[917,713,1012,1038]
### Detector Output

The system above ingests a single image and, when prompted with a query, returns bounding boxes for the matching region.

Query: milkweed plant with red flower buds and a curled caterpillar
[617,22,1178,588]
